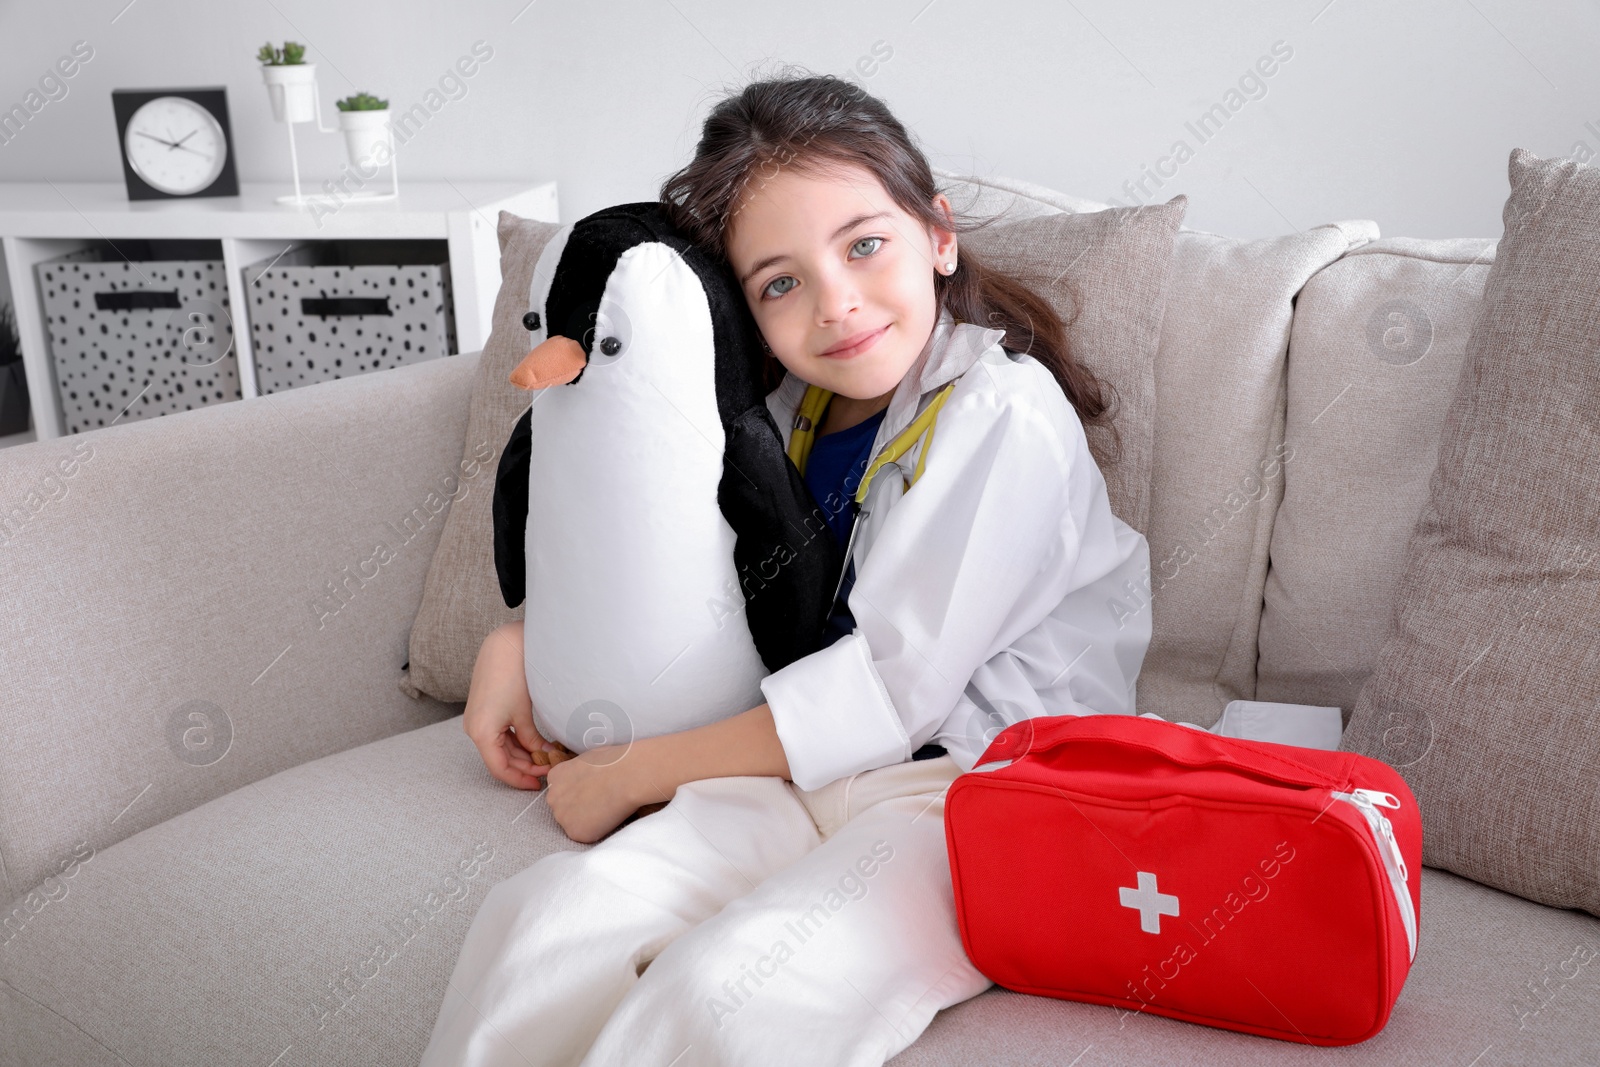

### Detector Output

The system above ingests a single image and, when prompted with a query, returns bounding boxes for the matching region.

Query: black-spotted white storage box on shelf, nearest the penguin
[243,242,456,394]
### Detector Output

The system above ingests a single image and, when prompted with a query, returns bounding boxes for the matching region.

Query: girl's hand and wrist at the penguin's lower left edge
[461,621,573,789]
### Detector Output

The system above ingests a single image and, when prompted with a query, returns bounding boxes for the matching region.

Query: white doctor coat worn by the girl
[760,312,1150,789]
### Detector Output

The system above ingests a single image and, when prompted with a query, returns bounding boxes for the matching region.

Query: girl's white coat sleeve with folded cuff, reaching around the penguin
[762,394,1093,789]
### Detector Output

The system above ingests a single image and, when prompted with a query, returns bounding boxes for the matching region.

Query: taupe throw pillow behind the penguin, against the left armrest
[400,211,562,701]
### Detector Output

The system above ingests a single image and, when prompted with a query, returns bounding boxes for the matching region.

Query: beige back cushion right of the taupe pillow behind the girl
[1139,221,1378,726]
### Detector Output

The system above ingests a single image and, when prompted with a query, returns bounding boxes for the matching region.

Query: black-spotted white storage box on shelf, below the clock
[34,242,242,434]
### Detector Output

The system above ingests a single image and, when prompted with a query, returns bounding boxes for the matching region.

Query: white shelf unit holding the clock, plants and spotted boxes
[0,181,560,446]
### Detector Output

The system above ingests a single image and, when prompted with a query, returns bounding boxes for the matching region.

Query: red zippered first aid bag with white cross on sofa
[944,715,1422,1045]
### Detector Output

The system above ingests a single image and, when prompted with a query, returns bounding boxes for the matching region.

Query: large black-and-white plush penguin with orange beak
[493,202,843,753]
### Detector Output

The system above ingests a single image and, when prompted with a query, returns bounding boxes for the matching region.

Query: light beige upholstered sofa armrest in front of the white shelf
[0,354,480,899]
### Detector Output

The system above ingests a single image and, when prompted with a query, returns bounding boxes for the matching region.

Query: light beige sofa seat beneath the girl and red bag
[0,704,1600,1067]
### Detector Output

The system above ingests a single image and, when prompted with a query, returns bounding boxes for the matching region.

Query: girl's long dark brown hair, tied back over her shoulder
[661,74,1120,458]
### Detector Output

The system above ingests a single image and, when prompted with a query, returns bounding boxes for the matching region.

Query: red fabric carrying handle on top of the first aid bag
[973,715,1342,787]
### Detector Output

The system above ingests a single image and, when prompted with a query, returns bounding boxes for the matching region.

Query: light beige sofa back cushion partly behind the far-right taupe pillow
[1256,237,1494,716]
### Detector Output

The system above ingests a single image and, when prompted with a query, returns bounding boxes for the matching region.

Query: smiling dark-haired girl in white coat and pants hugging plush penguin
[422,77,1150,1067]
